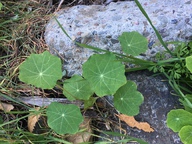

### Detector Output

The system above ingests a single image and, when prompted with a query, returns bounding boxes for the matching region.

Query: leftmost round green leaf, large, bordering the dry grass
[19,51,62,89]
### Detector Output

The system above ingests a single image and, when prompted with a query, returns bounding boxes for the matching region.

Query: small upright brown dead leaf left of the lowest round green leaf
[28,107,41,132]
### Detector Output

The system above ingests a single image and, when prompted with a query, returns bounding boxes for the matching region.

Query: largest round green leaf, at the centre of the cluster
[83,53,126,97]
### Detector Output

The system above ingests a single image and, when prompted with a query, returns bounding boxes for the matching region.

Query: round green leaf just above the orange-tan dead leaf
[114,81,144,116]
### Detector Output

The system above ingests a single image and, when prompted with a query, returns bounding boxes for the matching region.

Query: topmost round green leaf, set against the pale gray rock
[118,31,148,56]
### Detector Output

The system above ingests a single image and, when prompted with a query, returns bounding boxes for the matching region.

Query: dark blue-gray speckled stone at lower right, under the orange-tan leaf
[125,71,182,144]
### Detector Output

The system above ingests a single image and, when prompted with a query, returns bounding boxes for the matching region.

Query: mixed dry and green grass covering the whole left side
[0,0,59,143]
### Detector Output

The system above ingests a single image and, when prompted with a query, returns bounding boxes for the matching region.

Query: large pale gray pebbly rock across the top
[45,0,192,76]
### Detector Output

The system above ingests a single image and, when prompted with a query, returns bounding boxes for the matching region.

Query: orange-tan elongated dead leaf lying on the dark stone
[117,114,154,132]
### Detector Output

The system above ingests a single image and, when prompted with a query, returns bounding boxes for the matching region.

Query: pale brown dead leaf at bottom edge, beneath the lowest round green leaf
[67,118,92,144]
